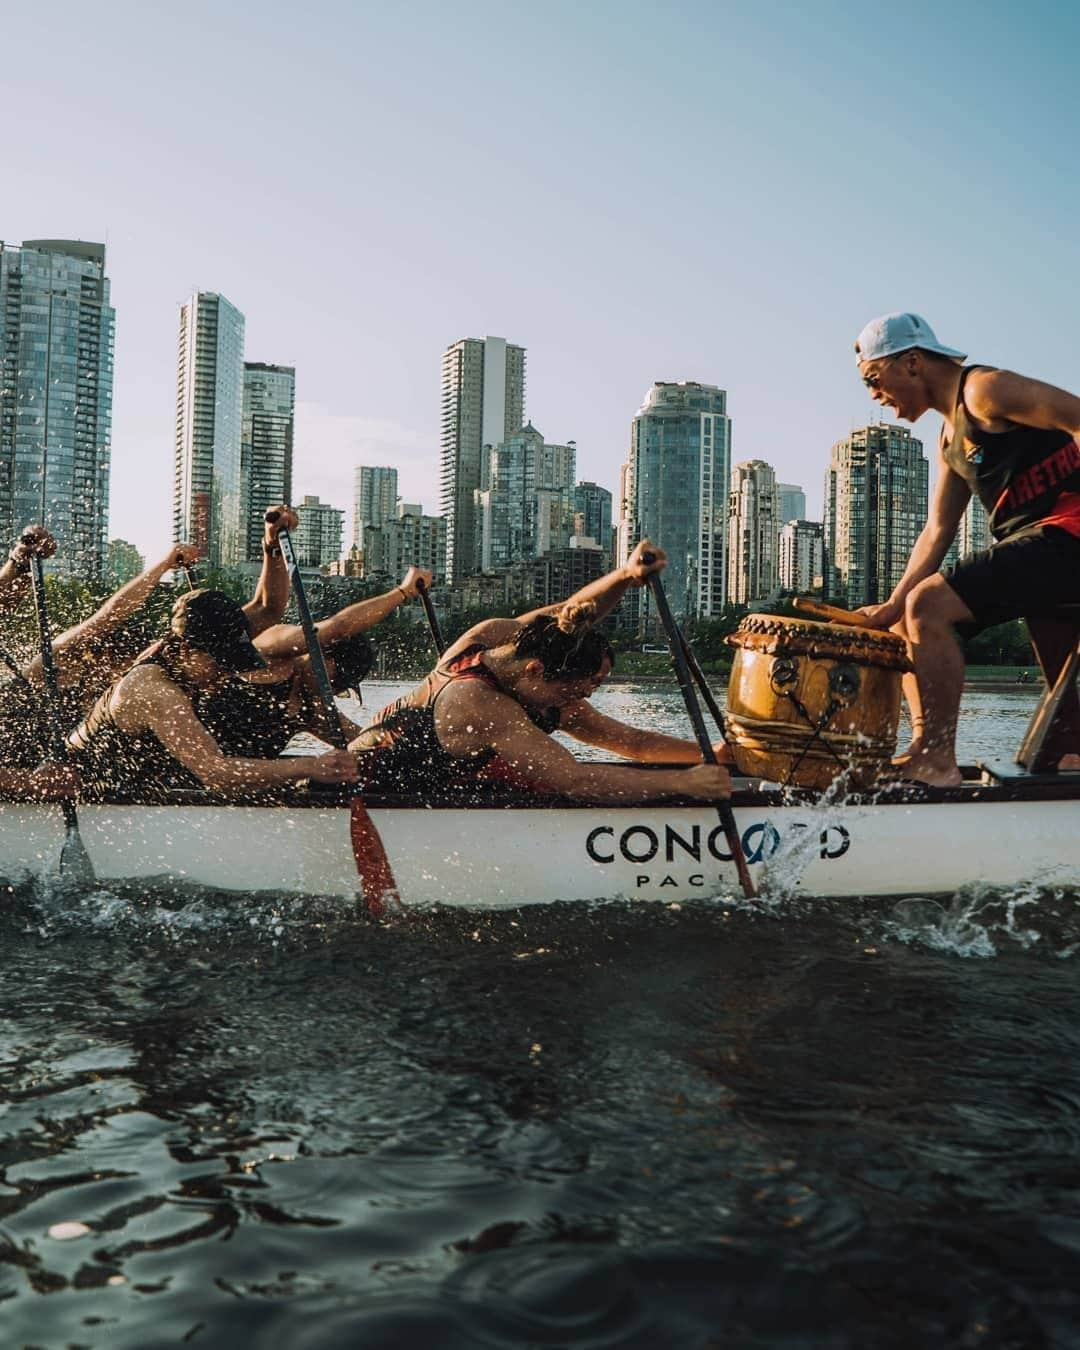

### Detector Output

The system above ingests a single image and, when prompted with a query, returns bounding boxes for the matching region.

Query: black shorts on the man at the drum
[945,525,1080,637]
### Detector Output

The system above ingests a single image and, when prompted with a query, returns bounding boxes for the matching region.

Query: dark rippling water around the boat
[0,689,1080,1350]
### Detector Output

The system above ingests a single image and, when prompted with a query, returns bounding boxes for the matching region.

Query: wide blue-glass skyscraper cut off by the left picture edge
[0,239,116,579]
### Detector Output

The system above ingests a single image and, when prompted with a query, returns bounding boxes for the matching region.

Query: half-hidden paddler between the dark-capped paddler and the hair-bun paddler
[203,567,432,759]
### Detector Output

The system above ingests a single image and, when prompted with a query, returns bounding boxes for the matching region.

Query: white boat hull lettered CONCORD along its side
[0,799,1080,909]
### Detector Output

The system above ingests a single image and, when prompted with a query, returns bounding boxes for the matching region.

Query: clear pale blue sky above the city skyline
[0,0,1080,555]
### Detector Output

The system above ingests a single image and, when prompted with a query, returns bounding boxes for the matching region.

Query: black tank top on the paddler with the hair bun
[352,644,559,798]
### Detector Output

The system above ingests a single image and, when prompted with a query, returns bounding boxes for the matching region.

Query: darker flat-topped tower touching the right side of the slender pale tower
[240,360,296,559]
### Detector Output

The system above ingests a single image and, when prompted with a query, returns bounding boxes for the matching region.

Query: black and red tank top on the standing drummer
[941,366,1080,539]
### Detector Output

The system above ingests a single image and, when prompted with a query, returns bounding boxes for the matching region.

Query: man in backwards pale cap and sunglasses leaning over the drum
[855,313,1080,786]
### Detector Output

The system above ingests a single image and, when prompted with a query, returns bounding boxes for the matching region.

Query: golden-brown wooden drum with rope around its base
[726,614,911,787]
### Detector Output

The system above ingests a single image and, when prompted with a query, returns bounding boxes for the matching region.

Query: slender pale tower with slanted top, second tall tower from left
[173,290,247,566]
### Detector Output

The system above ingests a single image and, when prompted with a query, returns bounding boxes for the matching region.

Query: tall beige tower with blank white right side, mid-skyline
[440,338,525,579]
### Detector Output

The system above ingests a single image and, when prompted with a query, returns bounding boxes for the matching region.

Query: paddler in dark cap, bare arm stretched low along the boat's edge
[68,590,356,801]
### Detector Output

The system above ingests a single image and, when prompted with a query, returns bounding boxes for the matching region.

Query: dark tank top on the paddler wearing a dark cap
[68,639,204,801]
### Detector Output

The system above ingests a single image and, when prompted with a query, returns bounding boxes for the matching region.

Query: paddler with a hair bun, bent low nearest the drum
[350,540,730,805]
